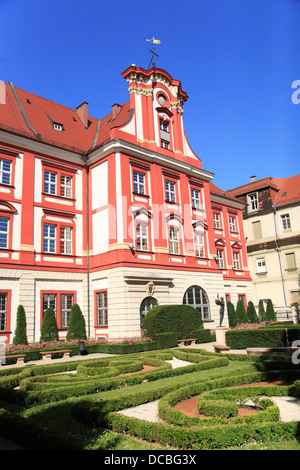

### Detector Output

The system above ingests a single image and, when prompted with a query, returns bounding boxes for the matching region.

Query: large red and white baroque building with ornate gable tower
[0,65,252,342]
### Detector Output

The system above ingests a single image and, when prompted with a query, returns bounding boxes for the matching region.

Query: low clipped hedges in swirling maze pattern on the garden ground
[0,348,300,449]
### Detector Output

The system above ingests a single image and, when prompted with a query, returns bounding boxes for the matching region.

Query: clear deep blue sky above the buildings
[0,0,300,189]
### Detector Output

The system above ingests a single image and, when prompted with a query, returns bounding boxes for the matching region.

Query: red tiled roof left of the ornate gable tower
[0,84,129,153]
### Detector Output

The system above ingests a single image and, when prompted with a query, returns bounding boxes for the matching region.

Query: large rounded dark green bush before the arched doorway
[142,305,203,339]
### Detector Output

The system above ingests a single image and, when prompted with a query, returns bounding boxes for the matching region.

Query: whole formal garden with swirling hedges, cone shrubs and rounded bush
[0,303,300,450]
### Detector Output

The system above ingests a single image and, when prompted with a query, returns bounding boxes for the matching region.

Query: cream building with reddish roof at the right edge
[228,175,300,319]
